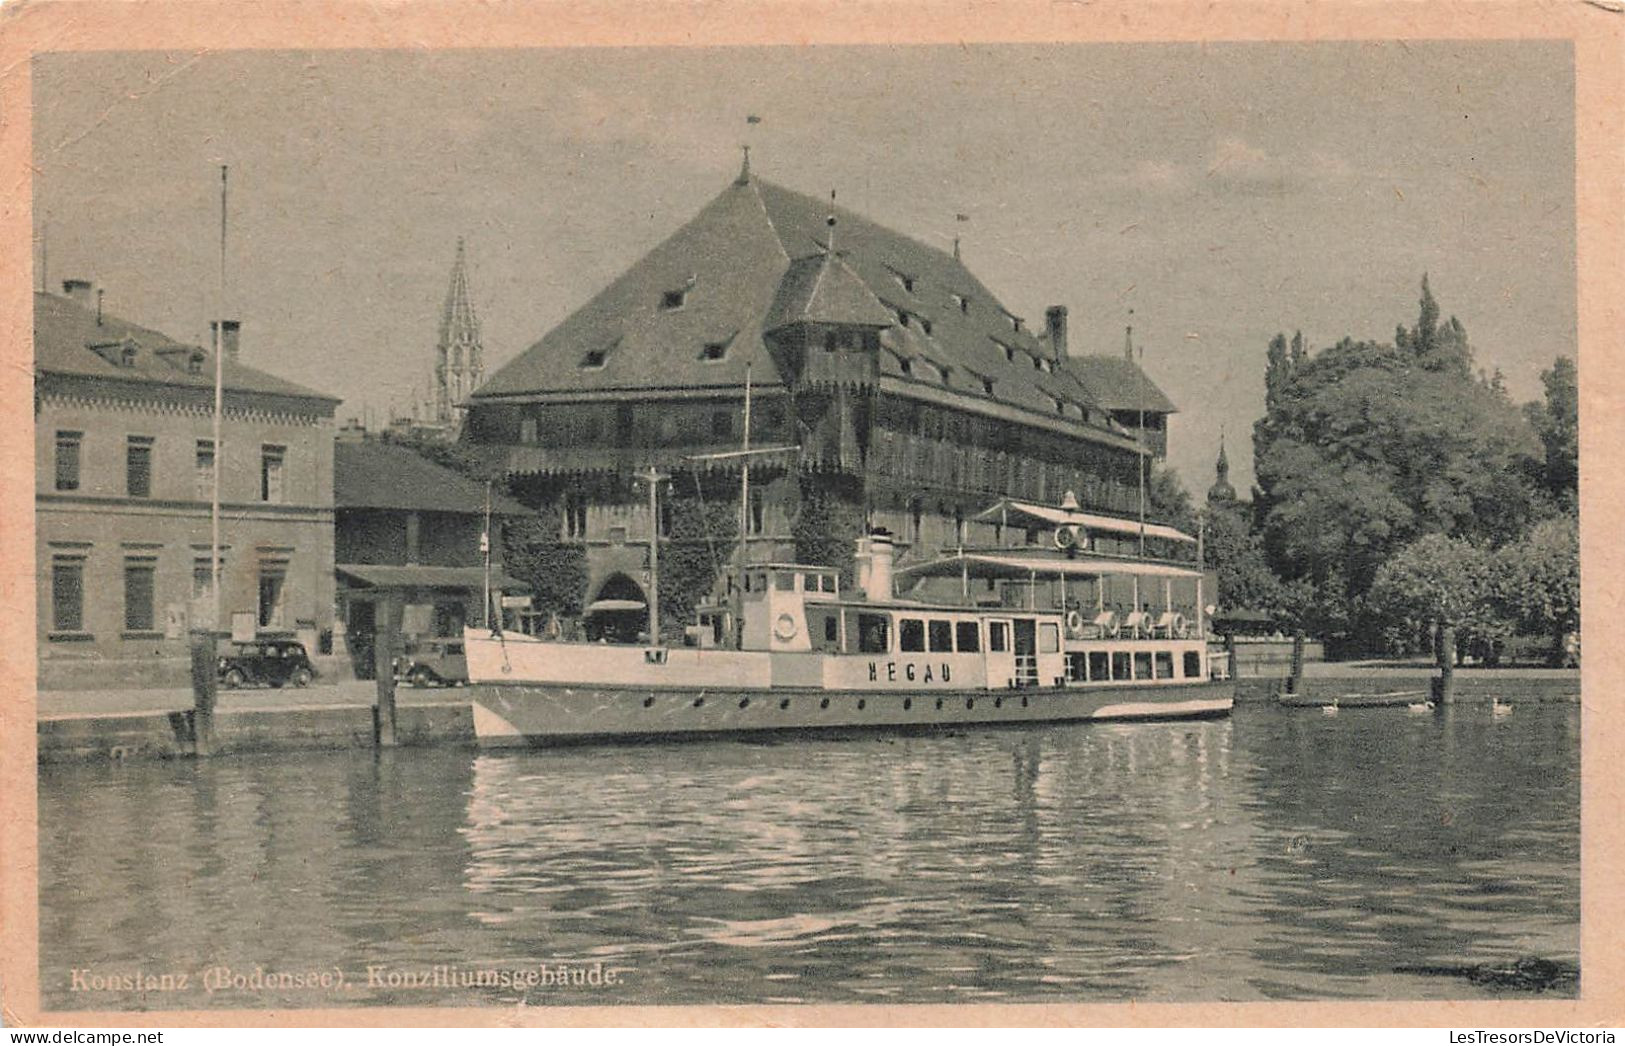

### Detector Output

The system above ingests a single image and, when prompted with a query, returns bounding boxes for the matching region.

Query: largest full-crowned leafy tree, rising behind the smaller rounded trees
[1253,281,1539,627]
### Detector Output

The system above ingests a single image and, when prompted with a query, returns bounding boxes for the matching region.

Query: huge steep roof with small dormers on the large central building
[473,175,1172,424]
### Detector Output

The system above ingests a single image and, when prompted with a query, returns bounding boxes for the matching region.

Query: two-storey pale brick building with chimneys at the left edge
[34,281,336,687]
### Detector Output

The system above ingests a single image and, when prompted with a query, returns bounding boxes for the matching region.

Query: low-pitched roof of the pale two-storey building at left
[34,291,338,406]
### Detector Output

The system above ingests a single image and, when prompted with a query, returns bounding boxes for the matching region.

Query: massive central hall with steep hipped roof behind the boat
[465,166,1173,627]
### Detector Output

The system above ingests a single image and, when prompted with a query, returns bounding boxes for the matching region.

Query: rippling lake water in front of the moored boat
[39,695,1580,1009]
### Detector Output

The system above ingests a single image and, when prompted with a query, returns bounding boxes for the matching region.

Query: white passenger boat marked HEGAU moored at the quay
[465,490,1233,747]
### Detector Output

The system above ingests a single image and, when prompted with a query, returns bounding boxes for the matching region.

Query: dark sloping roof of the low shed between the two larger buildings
[333,440,527,515]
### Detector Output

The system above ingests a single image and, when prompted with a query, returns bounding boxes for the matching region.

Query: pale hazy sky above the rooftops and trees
[34,41,1576,495]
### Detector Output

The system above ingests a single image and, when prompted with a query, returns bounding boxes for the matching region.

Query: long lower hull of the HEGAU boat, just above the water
[470,681,1235,747]
